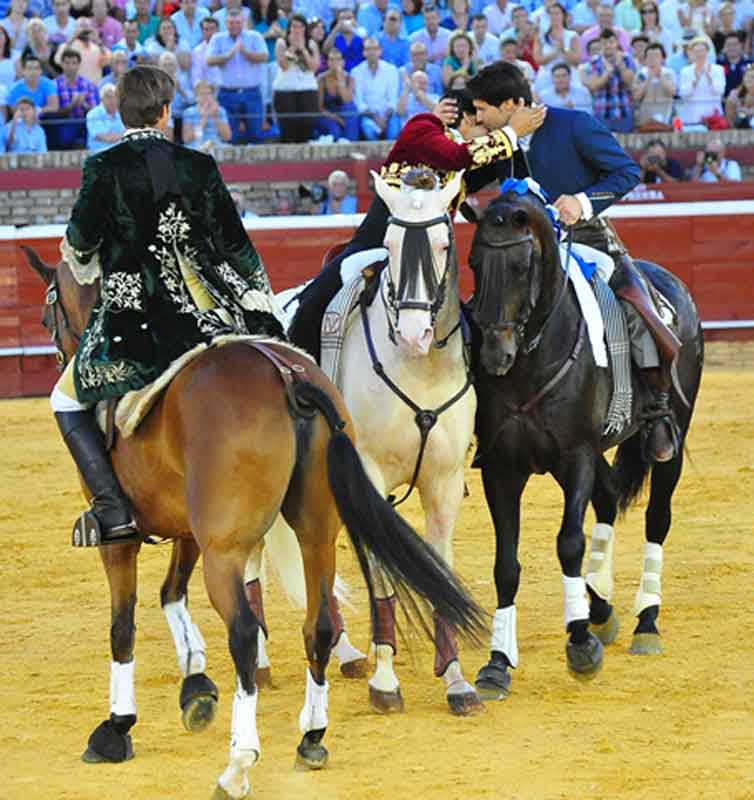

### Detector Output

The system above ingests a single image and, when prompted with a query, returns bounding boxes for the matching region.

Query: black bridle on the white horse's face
[380,212,460,348]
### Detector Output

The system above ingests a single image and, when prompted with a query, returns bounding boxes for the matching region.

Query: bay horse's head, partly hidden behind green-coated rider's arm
[21,245,99,368]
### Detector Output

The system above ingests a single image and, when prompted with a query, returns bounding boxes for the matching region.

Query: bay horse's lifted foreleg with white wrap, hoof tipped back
[160,539,218,733]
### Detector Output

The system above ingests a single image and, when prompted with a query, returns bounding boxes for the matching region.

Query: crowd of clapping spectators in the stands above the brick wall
[0,0,754,161]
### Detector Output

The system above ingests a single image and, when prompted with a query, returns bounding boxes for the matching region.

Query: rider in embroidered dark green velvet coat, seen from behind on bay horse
[50,66,283,543]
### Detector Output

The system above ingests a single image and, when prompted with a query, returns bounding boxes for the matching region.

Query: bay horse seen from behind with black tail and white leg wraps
[23,247,483,800]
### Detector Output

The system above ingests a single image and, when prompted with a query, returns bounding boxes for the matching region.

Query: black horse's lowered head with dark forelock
[462,191,558,376]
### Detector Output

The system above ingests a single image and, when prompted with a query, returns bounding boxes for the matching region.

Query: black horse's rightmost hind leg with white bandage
[631,448,683,655]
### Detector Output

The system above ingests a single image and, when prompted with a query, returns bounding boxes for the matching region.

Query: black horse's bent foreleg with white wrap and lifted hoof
[553,449,603,678]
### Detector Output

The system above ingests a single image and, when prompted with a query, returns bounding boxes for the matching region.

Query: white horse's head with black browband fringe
[372,169,463,356]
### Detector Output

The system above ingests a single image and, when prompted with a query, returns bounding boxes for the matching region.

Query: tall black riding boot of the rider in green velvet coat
[55,411,138,545]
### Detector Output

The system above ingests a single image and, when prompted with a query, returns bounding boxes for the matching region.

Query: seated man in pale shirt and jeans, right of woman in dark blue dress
[351,36,400,141]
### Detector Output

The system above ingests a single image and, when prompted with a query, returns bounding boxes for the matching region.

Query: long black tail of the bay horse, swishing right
[297,383,487,643]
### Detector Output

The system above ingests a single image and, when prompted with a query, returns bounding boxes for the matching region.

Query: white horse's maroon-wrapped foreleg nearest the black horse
[420,464,482,715]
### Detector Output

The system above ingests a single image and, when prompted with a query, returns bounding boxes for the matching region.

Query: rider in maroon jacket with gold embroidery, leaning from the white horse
[288,91,545,360]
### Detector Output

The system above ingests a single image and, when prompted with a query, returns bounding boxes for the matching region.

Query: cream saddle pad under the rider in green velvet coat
[97,335,313,438]
